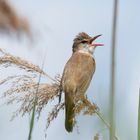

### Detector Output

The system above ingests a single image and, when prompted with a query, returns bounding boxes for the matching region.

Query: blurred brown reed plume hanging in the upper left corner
[0,0,31,37]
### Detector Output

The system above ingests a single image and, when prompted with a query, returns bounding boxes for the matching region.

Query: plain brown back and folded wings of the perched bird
[62,52,95,95]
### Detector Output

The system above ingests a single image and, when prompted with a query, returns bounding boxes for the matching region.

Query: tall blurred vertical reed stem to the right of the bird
[110,0,118,140]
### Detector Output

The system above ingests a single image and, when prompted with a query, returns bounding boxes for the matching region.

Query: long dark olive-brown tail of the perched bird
[65,93,74,132]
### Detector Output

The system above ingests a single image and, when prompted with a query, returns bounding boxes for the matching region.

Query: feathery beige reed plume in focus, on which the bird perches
[0,49,98,128]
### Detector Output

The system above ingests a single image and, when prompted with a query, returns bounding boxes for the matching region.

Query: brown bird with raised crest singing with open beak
[61,32,103,132]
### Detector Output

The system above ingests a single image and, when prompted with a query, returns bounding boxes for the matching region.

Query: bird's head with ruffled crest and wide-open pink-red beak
[73,32,103,54]
